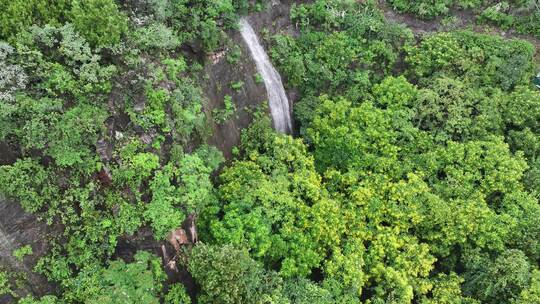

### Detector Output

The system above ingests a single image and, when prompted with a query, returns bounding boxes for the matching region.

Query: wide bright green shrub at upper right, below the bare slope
[406,31,534,90]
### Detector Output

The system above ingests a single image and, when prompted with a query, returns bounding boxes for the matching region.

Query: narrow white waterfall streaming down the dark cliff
[240,18,293,133]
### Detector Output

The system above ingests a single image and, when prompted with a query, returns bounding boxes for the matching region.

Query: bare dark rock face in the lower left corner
[0,198,59,303]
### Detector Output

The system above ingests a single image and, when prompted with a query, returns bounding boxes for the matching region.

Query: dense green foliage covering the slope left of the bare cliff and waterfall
[0,0,235,303]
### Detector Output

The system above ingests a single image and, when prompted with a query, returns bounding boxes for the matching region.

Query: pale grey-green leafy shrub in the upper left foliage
[16,24,116,98]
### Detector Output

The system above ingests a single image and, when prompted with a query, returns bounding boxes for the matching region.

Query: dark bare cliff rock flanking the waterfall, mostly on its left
[203,1,296,159]
